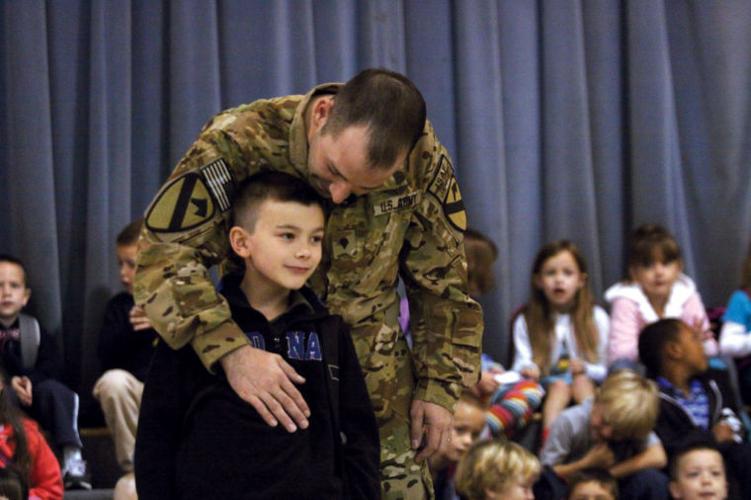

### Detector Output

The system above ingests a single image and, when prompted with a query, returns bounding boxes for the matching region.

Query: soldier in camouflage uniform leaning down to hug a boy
[135,69,482,498]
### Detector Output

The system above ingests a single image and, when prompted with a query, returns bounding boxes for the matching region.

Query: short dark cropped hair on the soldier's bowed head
[321,68,426,169]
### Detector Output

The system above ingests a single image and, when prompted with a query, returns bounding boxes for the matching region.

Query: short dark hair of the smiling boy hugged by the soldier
[232,171,324,231]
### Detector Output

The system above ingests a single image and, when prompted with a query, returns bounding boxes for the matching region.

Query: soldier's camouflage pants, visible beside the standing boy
[353,325,434,500]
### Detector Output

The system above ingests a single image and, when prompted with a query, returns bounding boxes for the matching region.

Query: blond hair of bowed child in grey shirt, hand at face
[595,370,660,440]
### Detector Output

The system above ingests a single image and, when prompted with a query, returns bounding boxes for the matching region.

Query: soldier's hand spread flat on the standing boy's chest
[219,345,310,432]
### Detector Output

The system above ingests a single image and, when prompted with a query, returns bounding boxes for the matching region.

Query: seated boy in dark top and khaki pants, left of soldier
[93,219,157,486]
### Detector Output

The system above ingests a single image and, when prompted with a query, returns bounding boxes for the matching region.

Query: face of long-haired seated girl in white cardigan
[535,250,587,312]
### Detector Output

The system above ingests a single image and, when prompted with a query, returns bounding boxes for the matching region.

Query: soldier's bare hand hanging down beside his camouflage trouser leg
[409,399,454,462]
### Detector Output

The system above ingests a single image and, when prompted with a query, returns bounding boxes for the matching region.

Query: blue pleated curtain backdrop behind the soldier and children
[0,0,751,414]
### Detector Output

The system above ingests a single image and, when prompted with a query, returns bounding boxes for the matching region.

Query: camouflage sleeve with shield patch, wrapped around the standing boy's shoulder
[133,132,247,369]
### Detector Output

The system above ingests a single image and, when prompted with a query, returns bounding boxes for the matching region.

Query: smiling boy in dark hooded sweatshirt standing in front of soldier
[135,172,380,500]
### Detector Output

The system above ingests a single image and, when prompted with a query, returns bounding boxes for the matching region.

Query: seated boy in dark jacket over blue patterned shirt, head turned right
[639,319,751,498]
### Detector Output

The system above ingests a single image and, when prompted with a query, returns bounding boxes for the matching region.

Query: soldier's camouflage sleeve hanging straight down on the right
[401,121,483,412]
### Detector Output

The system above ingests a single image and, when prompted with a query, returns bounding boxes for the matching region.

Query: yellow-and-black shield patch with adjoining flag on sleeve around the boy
[146,158,233,233]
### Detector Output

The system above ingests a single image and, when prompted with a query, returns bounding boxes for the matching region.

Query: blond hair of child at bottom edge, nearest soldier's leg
[456,440,541,500]
